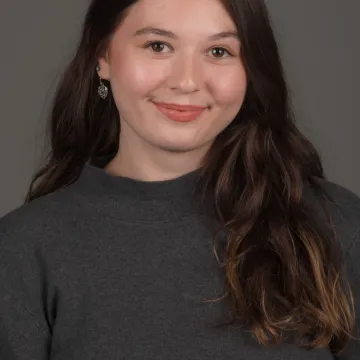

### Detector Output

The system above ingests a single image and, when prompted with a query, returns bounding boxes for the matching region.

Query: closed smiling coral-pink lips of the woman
[153,102,207,122]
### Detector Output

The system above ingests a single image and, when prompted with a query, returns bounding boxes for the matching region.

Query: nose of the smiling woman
[169,54,201,93]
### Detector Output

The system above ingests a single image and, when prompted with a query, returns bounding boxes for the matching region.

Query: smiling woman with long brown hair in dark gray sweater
[0,0,360,360]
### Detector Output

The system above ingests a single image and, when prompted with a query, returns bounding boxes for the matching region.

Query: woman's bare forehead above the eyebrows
[121,0,236,36]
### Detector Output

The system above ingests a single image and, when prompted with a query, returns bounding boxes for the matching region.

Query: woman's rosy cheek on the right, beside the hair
[209,67,247,107]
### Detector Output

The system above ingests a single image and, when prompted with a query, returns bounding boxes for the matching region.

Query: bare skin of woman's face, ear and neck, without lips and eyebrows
[98,0,246,181]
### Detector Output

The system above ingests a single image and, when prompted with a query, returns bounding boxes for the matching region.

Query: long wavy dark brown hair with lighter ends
[25,0,355,353]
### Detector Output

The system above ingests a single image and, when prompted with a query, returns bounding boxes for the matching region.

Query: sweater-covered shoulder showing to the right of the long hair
[304,179,360,249]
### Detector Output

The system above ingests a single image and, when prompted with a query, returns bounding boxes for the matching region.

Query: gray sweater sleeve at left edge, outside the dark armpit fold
[0,215,51,360]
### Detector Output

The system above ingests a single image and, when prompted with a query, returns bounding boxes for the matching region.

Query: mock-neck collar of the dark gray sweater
[77,164,207,222]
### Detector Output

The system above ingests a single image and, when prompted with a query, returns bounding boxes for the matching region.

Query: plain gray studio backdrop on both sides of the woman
[0,0,360,216]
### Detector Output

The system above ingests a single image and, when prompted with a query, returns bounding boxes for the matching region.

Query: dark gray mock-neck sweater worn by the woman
[0,165,360,360]
